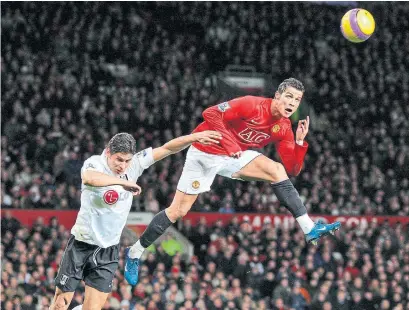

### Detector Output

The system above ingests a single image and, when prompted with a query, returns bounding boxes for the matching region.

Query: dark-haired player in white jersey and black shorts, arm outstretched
[50,130,221,310]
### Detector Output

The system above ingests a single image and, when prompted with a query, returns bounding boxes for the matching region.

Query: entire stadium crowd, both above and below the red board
[1,2,409,310]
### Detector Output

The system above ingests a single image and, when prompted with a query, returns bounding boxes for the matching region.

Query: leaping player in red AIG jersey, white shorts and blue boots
[125,78,340,284]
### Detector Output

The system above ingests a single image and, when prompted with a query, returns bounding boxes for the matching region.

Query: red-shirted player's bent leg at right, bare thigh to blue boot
[232,155,341,244]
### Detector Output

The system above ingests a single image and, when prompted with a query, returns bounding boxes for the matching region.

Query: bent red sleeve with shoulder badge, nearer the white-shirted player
[203,96,257,155]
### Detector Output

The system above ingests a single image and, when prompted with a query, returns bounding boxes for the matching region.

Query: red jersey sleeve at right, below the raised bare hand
[276,127,308,176]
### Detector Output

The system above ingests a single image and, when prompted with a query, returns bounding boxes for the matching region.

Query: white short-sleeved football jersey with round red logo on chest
[71,148,154,248]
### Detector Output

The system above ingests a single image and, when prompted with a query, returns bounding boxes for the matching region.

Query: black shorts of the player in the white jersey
[55,235,119,293]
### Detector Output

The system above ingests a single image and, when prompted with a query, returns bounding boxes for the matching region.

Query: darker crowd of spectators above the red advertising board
[1,2,409,215]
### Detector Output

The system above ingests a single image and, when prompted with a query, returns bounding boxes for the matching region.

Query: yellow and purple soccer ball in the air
[341,9,375,43]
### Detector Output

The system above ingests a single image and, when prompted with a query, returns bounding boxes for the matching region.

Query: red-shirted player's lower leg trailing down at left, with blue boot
[125,190,198,285]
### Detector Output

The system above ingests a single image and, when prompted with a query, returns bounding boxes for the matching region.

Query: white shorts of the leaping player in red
[177,146,261,194]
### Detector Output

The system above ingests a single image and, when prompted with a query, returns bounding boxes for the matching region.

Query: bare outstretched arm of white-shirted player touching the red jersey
[153,130,222,162]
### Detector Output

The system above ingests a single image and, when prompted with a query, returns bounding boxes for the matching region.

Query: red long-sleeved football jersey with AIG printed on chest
[193,96,308,175]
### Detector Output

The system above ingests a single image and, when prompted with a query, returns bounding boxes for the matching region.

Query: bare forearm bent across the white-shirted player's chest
[81,170,142,195]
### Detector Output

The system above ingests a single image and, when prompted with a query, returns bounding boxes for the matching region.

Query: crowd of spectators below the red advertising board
[1,216,409,310]
